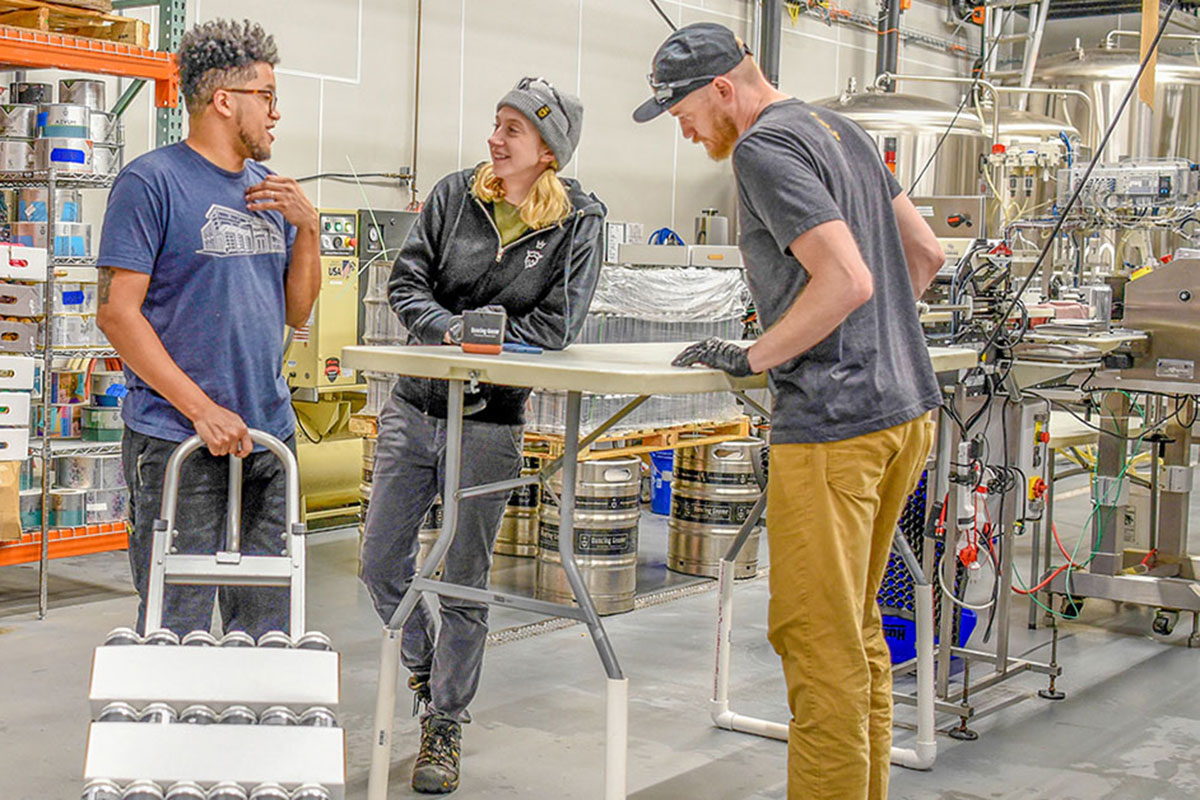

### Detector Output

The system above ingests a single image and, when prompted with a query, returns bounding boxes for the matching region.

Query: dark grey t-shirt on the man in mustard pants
[733,100,940,444]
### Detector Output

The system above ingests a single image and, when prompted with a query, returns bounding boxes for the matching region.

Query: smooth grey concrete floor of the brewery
[0,472,1200,800]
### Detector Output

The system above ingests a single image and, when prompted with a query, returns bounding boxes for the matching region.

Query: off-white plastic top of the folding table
[342,342,978,395]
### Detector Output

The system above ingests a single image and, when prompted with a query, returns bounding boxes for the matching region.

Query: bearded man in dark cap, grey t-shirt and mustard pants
[634,23,943,800]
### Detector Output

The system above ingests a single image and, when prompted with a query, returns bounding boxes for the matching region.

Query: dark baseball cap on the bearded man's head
[634,23,750,122]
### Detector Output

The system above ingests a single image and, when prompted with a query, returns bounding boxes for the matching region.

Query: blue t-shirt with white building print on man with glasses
[97,142,295,441]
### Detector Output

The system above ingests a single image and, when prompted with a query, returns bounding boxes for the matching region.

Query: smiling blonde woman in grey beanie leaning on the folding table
[352,78,606,793]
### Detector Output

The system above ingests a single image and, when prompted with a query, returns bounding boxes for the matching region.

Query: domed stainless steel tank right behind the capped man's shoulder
[812,88,989,197]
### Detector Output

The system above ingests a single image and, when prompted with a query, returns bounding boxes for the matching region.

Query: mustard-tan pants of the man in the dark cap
[767,415,934,800]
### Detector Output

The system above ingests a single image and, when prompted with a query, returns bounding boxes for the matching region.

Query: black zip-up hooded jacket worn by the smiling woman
[388,168,607,425]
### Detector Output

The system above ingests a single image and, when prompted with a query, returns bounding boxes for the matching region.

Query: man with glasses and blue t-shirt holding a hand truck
[97,20,320,637]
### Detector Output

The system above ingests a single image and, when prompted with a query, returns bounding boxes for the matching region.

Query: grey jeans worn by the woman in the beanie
[362,395,523,722]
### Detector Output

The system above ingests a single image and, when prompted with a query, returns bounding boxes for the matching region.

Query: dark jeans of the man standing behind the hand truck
[121,428,295,639]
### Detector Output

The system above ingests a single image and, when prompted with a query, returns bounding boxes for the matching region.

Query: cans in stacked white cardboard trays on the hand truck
[82,627,346,800]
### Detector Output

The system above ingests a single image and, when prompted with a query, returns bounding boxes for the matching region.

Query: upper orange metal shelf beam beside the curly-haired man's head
[0,26,179,108]
